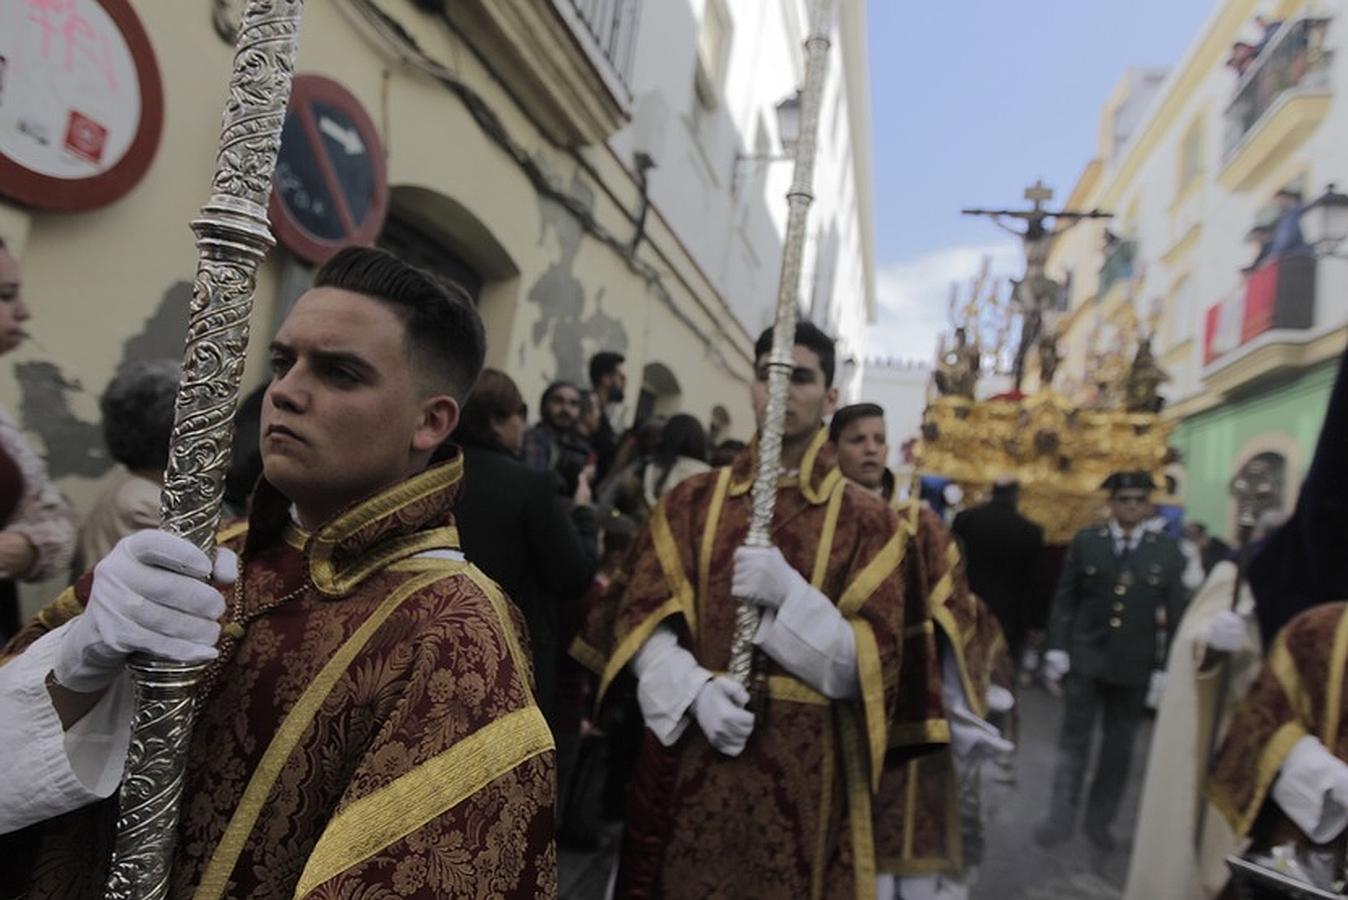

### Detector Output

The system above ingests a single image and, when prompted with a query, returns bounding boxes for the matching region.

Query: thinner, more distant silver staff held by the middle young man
[729,0,833,688]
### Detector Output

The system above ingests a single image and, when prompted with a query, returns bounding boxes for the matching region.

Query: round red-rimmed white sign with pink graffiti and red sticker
[0,0,163,212]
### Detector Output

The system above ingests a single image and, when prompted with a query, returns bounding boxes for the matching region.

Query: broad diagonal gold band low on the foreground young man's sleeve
[295,705,553,897]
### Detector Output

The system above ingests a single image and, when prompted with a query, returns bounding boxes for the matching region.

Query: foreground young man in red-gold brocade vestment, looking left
[0,248,557,900]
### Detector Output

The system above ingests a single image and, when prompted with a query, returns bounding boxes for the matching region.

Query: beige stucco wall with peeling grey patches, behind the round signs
[0,0,752,614]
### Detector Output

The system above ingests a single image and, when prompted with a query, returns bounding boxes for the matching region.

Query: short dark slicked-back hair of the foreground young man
[314,247,487,403]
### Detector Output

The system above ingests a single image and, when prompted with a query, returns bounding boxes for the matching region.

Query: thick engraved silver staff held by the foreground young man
[106,0,303,900]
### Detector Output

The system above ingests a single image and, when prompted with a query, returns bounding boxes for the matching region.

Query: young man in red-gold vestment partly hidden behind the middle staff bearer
[829,403,1014,900]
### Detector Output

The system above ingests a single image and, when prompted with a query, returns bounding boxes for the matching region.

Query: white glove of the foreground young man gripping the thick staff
[53,529,239,693]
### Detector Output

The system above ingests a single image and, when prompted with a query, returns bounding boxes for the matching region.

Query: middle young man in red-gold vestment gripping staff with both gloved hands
[574,322,940,900]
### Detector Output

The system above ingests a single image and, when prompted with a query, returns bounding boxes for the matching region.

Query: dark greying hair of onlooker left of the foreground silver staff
[98,360,182,472]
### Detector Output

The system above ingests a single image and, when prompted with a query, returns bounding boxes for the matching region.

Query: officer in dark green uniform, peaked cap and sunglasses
[1035,472,1188,853]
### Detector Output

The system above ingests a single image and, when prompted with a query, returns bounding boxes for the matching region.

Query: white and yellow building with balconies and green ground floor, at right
[1049,0,1348,536]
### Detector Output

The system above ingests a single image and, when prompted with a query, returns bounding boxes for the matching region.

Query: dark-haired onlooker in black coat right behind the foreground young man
[433,369,599,725]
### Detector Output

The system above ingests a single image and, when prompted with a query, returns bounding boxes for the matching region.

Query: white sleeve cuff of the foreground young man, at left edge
[0,625,132,834]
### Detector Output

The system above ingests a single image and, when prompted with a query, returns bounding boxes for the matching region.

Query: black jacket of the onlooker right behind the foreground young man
[444,439,599,719]
